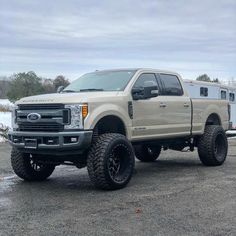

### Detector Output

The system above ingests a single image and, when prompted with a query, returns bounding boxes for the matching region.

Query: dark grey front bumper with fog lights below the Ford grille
[8,130,93,152]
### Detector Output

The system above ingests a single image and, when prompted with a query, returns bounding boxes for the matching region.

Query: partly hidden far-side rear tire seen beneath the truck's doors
[134,144,161,162]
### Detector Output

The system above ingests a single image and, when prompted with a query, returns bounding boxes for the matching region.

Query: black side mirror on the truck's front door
[131,86,159,100]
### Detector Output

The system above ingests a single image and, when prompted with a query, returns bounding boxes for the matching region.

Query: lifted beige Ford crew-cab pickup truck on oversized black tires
[9,69,230,189]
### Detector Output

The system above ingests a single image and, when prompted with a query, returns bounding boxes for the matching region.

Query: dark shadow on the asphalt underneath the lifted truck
[9,159,204,194]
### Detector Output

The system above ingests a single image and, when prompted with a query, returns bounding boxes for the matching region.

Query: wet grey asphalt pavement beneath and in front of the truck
[0,140,236,236]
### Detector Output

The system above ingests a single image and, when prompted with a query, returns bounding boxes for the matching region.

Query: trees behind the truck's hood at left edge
[0,71,70,102]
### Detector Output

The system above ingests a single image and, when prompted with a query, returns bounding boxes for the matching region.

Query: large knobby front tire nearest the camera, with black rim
[87,133,135,190]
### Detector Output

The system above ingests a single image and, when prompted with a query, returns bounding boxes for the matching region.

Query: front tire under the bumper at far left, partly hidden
[11,148,55,181]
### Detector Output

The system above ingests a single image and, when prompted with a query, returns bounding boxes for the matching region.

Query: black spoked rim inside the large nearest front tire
[108,144,132,184]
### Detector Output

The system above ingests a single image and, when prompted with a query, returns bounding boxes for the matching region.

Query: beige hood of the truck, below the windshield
[16,91,119,105]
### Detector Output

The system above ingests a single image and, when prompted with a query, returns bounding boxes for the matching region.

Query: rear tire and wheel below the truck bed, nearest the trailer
[198,125,228,166]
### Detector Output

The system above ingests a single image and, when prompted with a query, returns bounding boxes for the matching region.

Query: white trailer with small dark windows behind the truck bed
[184,80,236,129]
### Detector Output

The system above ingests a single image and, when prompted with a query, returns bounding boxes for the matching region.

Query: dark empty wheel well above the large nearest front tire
[94,115,126,135]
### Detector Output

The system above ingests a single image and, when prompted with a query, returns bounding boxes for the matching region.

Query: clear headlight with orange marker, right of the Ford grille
[65,104,88,129]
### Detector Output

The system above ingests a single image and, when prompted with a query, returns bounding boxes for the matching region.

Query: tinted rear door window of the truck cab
[159,74,184,96]
